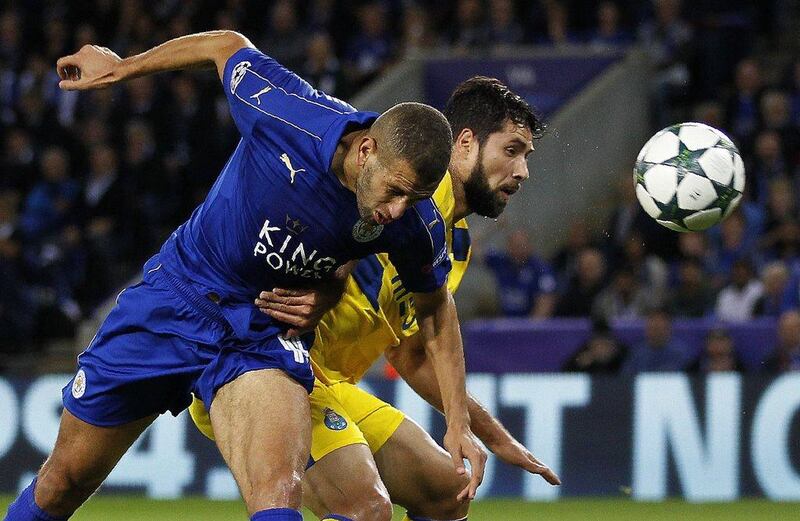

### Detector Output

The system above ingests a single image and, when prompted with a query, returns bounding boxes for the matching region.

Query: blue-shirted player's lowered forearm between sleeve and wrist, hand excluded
[415,290,469,426]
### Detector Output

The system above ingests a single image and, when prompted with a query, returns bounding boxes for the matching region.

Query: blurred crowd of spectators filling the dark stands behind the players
[0,0,800,370]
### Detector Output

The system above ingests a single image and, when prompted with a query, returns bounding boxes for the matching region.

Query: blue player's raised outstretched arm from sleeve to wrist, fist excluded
[115,31,253,81]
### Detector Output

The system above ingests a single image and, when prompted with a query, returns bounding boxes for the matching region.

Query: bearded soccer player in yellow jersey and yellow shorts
[190,77,560,521]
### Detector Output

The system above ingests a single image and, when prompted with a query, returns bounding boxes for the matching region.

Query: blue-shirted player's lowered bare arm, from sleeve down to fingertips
[414,286,486,499]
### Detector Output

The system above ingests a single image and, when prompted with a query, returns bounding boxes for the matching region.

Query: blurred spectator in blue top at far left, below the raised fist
[20,147,80,241]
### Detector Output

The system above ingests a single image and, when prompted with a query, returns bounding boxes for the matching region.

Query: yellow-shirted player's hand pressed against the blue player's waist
[255,287,341,337]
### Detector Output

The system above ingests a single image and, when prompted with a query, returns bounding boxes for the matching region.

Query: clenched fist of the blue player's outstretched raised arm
[56,45,122,90]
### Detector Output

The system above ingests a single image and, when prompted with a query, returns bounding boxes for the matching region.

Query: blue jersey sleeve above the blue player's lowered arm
[388,199,451,293]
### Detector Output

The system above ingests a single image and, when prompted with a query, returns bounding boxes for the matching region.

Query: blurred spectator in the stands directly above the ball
[639,0,694,128]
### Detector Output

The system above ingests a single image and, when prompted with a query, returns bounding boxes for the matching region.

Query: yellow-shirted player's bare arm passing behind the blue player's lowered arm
[385,337,561,485]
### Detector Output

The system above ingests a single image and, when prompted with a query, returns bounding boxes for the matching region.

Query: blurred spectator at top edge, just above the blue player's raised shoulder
[260,0,307,70]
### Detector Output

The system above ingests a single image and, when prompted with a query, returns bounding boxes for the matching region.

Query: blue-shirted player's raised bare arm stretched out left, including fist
[56,31,253,90]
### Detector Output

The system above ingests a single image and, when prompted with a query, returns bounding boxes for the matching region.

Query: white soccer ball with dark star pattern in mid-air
[633,123,744,232]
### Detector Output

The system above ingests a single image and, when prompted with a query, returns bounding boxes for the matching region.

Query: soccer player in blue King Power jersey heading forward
[6,31,486,521]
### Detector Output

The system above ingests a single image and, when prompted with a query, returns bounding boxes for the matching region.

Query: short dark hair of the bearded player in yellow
[444,76,545,143]
